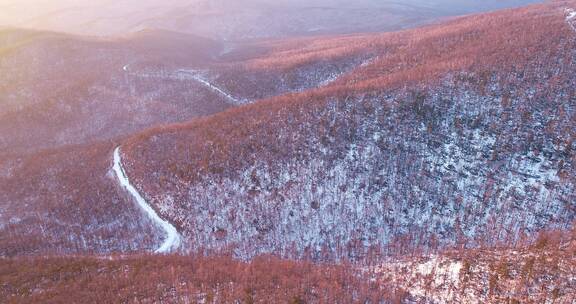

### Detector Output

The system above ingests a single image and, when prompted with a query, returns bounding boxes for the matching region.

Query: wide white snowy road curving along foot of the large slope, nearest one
[113,147,180,254]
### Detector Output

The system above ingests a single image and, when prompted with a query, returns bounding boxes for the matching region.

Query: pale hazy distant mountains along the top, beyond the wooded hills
[0,0,538,39]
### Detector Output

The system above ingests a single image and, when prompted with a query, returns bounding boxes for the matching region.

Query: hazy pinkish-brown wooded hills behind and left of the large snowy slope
[0,29,384,256]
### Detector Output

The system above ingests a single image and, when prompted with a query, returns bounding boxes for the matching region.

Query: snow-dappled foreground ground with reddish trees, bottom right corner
[372,244,576,304]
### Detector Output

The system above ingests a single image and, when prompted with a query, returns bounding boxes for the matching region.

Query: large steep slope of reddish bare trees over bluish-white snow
[123,2,576,259]
